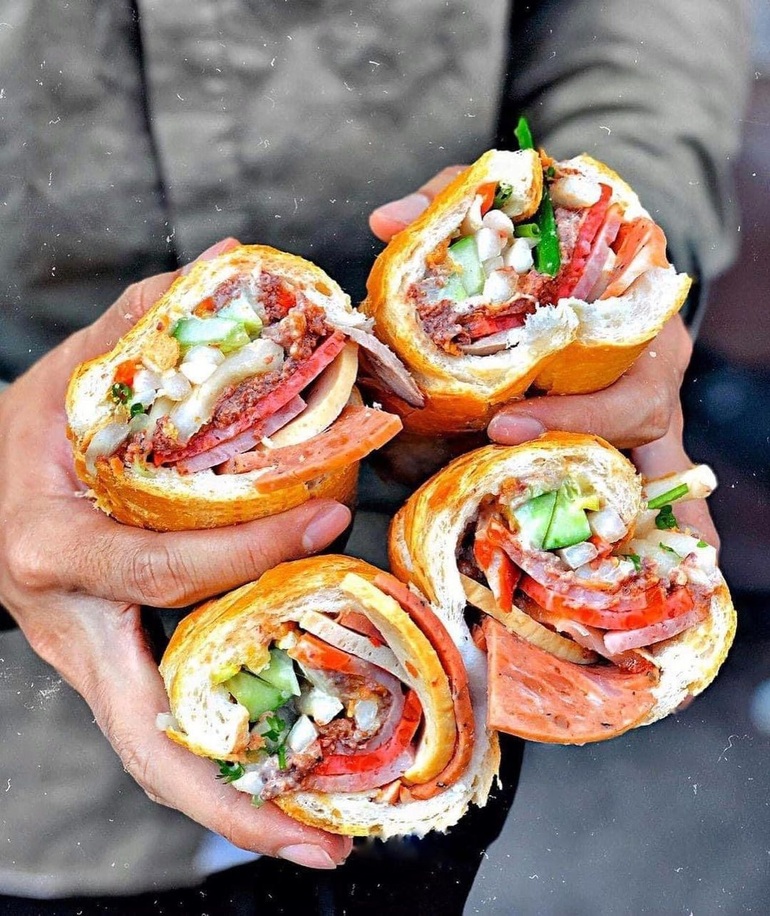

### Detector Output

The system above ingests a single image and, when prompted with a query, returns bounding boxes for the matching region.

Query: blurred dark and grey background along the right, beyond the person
[466,0,770,916]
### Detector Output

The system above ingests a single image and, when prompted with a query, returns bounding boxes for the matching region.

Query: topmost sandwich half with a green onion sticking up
[362,117,690,434]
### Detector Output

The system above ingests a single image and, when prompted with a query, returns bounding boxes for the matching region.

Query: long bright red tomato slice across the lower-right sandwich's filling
[521,575,692,630]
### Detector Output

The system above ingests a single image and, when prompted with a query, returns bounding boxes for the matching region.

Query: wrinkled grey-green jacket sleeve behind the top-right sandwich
[499,0,750,325]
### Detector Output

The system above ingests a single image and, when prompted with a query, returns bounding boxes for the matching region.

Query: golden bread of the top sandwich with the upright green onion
[362,150,690,435]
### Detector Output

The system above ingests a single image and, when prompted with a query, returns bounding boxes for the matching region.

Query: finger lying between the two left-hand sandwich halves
[54,500,350,608]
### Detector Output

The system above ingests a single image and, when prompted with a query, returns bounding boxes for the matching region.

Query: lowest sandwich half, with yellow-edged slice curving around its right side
[158,556,499,837]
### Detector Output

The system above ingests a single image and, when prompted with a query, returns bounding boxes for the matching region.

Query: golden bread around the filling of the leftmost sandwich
[66,245,376,531]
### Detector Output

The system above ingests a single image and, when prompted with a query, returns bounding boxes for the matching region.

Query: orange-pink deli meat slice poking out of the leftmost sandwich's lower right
[219,407,402,484]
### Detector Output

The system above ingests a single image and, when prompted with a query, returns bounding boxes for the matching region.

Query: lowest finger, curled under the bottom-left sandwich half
[82,609,351,868]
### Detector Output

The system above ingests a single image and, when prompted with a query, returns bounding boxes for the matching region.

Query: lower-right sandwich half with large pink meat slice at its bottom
[390,433,735,744]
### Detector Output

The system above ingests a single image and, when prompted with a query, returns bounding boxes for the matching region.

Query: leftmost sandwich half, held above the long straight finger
[67,245,420,530]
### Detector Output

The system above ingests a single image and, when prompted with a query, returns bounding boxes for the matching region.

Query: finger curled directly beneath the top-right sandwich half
[487,317,692,448]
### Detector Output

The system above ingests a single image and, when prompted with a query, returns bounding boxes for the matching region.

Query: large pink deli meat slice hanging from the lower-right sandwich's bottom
[482,618,660,744]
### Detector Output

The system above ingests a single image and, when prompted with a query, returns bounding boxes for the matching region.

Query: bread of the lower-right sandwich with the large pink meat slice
[389,432,736,737]
